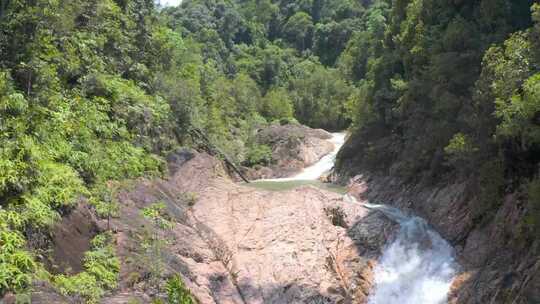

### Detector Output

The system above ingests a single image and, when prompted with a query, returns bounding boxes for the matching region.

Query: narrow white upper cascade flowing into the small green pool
[259,133,347,182]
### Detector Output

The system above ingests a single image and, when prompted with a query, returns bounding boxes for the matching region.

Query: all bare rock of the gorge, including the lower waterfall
[9,126,539,304]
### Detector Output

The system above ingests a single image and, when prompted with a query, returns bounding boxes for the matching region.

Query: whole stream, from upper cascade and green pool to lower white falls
[252,133,458,304]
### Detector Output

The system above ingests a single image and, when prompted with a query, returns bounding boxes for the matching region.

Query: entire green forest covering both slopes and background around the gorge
[0,0,540,303]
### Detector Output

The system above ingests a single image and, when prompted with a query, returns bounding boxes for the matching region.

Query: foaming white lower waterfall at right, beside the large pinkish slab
[365,204,457,304]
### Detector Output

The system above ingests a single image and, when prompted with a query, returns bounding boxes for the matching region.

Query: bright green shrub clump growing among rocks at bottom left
[54,234,120,304]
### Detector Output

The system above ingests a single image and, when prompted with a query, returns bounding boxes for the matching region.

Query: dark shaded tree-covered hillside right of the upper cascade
[338,0,540,239]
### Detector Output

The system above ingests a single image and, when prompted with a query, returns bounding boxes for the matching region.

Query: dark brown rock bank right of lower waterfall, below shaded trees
[349,176,540,304]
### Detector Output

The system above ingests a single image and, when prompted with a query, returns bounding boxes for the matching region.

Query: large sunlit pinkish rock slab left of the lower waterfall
[97,154,393,303]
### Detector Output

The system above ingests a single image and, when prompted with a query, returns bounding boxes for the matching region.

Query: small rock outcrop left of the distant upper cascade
[245,124,334,180]
